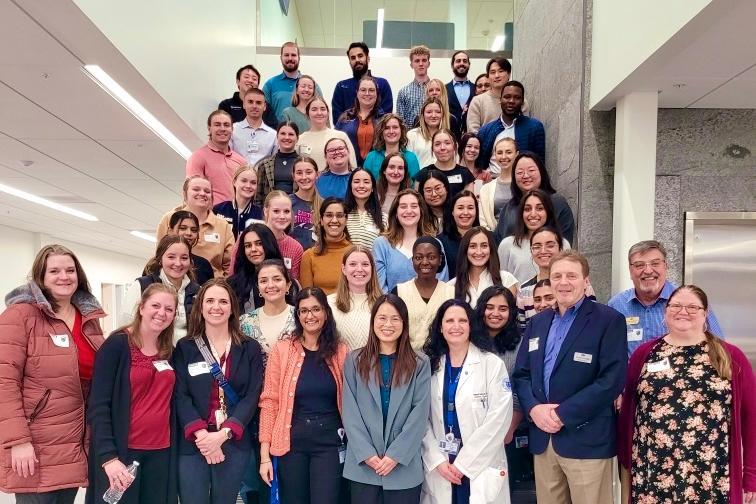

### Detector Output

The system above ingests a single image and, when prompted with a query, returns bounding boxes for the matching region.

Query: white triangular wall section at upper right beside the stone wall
[590,0,715,107]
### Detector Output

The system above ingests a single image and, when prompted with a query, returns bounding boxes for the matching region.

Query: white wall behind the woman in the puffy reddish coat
[0,226,147,312]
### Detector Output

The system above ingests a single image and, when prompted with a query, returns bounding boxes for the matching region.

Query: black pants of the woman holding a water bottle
[114,448,171,504]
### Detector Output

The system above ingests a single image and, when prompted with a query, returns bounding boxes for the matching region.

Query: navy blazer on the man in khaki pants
[513,299,627,459]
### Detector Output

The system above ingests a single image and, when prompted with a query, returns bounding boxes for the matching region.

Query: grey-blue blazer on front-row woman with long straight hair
[343,349,431,490]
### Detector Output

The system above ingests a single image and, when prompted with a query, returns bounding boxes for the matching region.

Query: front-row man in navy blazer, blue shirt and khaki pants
[513,250,627,504]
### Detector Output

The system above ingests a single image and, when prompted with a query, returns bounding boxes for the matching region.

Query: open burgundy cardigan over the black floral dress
[617,338,756,504]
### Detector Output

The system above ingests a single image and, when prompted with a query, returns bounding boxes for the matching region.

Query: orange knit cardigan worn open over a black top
[260,339,348,457]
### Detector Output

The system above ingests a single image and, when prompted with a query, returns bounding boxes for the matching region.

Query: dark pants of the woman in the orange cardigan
[278,413,343,504]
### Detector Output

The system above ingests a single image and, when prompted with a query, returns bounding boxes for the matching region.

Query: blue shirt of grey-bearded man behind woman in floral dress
[607,280,724,357]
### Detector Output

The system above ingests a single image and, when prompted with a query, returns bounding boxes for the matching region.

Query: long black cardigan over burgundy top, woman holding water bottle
[86,331,178,504]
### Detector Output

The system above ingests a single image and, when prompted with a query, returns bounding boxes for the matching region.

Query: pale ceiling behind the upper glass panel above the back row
[292,0,514,50]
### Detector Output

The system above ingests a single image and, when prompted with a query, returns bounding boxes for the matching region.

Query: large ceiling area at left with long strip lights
[0,0,199,257]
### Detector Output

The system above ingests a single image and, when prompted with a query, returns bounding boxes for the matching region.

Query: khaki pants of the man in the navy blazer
[534,441,614,504]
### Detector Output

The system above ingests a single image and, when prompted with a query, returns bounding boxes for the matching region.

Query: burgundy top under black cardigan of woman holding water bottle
[128,345,176,450]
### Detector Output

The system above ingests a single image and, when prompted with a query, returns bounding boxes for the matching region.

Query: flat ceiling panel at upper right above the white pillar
[594,0,756,110]
